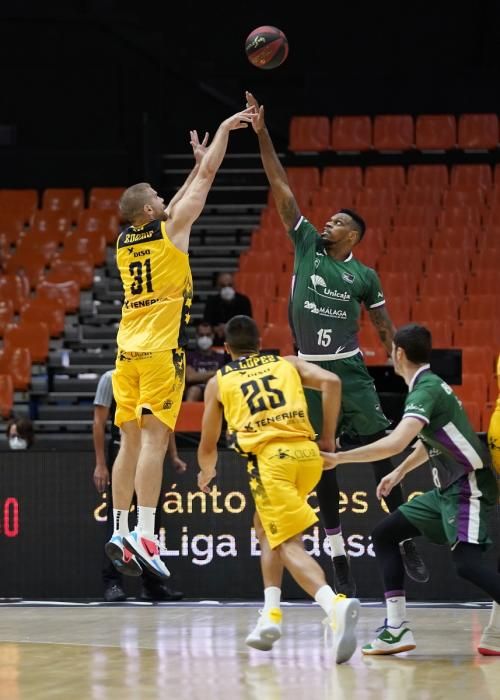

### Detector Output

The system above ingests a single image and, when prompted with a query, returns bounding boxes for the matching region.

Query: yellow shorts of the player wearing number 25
[247,440,323,549]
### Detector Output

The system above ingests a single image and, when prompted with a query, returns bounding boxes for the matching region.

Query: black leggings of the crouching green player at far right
[372,510,500,603]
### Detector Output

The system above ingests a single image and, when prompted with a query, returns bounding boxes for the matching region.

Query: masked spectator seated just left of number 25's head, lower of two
[185,321,225,401]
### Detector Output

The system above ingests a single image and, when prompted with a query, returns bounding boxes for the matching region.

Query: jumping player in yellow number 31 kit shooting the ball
[106,108,253,577]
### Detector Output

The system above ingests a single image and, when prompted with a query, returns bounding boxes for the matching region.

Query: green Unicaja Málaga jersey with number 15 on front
[290,216,385,360]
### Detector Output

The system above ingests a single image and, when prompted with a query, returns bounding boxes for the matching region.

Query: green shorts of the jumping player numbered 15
[305,353,390,439]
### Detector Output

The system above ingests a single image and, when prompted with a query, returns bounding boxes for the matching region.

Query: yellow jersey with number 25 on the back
[217,354,315,454]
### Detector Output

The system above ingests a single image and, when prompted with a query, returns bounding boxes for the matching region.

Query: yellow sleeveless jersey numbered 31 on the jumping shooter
[116,221,193,352]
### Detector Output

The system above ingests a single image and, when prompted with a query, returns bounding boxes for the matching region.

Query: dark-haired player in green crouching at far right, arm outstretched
[323,324,500,655]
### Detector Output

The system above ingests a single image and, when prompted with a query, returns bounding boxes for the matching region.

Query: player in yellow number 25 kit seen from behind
[198,316,360,663]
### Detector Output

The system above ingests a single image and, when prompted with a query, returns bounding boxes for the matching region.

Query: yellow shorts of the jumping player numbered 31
[112,348,186,430]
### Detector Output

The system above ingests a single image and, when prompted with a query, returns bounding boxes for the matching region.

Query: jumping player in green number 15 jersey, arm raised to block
[246,92,428,596]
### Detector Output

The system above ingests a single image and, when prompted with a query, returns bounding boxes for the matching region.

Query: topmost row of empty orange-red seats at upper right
[289,114,499,153]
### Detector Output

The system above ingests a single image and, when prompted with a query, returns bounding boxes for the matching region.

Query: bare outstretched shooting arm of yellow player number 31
[168,107,255,253]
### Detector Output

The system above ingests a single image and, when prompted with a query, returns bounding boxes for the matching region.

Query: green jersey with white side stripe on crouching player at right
[403,365,491,488]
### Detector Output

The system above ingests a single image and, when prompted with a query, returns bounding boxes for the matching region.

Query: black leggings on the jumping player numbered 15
[316,432,404,530]
